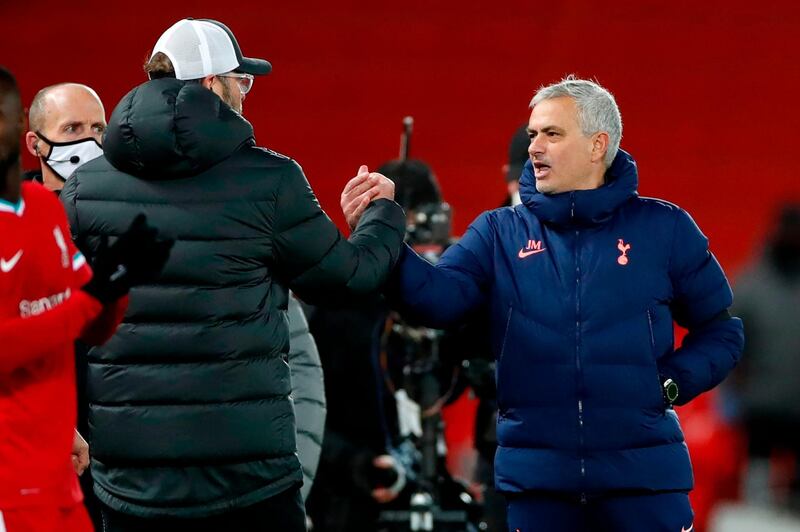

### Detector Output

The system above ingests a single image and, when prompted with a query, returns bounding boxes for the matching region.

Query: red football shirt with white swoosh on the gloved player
[0,183,104,510]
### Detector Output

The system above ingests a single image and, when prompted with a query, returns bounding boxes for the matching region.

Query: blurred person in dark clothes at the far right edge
[733,203,800,512]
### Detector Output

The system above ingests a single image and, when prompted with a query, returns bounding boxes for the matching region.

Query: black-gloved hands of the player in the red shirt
[83,214,174,305]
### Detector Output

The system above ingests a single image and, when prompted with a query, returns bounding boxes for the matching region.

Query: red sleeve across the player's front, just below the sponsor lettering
[0,290,103,373]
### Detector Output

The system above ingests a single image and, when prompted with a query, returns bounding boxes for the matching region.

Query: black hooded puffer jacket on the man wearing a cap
[61,79,405,517]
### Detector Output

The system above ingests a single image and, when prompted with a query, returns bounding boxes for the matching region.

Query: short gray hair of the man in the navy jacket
[530,75,622,167]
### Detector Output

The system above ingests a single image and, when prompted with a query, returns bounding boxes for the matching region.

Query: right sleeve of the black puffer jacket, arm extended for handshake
[273,162,405,303]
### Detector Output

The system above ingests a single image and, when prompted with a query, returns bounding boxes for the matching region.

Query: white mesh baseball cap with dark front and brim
[150,18,272,80]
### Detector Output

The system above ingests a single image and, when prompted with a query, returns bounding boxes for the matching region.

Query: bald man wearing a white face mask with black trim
[24,83,106,529]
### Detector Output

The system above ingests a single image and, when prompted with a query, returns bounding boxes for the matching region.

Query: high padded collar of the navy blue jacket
[519,150,639,226]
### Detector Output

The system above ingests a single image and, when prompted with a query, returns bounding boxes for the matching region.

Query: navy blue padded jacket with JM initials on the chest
[389,150,744,495]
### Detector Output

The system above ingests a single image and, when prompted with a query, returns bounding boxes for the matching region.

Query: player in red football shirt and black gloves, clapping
[0,67,171,532]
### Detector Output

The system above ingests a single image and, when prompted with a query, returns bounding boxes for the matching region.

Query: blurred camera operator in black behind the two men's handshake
[307,159,441,532]
